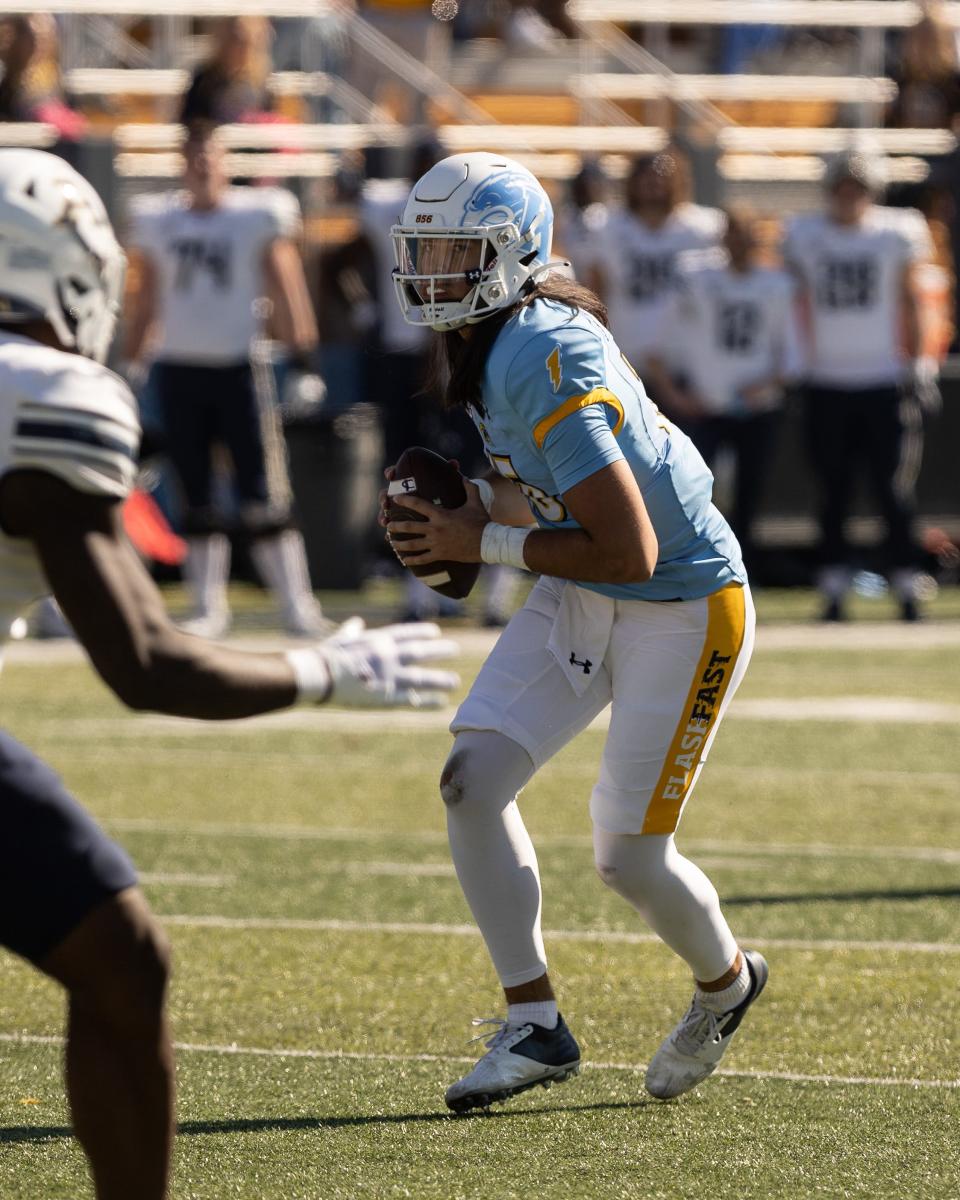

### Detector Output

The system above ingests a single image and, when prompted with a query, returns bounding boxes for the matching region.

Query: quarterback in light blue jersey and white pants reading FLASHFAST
[382,154,767,1111]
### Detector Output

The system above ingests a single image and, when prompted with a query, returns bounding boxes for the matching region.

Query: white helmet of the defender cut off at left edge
[0,150,126,362]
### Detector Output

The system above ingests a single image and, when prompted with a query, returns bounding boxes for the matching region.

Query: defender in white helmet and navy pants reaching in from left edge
[0,150,455,1200]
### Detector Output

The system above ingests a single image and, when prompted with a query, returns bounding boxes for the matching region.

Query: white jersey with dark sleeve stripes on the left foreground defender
[0,332,140,642]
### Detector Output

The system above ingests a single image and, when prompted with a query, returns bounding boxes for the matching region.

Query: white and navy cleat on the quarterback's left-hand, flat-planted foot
[446,1016,580,1112]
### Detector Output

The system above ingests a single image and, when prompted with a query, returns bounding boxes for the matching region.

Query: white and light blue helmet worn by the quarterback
[391,152,560,330]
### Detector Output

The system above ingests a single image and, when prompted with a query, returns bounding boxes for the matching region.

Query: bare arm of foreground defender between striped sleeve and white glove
[0,470,296,720]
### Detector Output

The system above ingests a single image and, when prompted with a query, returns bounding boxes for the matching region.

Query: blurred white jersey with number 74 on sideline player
[130,187,300,366]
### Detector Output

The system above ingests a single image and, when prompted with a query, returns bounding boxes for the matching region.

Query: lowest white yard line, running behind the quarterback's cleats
[0,1033,960,1090]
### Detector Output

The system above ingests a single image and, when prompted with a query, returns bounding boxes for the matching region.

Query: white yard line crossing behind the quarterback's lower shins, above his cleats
[157,913,960,954]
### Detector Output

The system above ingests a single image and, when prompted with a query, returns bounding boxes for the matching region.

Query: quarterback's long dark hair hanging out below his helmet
[425,274,610,413]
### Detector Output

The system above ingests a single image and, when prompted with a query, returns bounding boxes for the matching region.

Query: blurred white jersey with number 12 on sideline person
[656,264,803,414]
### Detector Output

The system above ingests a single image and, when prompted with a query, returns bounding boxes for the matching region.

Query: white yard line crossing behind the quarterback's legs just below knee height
[101,817,960,864]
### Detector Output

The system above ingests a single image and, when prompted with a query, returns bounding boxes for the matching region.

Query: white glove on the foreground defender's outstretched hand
[287,617,460,708]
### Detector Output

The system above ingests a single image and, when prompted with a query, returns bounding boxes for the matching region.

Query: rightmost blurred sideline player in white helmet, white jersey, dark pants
[784,151,938,620]
